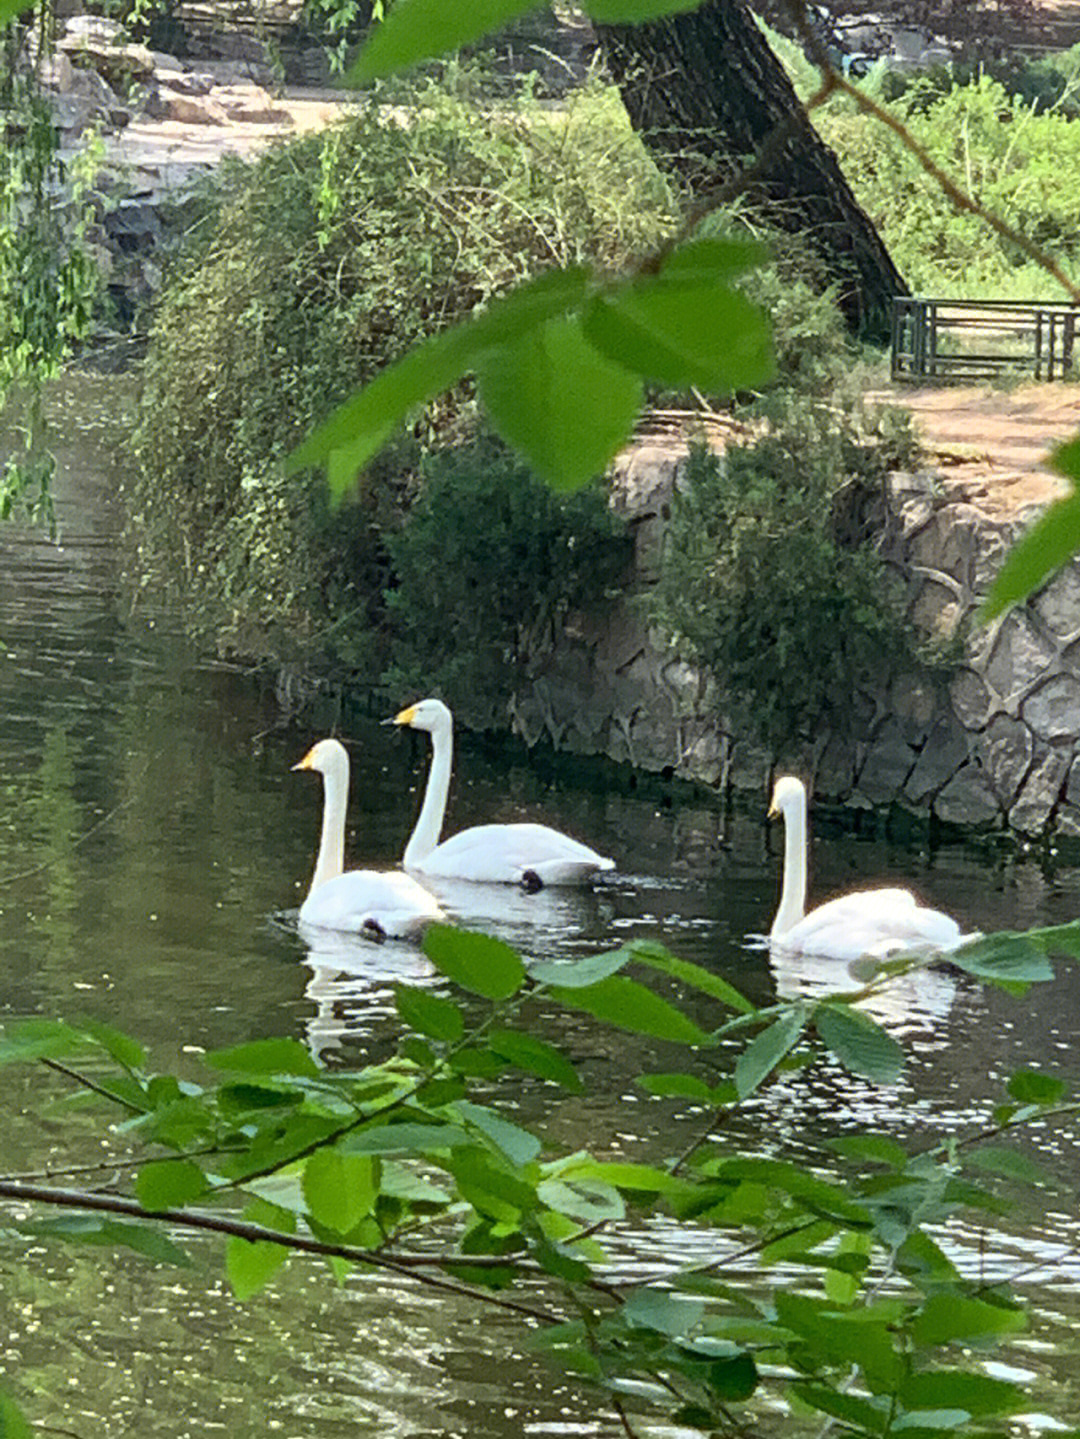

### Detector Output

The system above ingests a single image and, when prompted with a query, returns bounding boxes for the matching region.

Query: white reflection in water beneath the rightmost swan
[769,945,958,1043]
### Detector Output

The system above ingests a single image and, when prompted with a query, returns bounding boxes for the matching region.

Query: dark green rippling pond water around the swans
[0,380,1080,1439]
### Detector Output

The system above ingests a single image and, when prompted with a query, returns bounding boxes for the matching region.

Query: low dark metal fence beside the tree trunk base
[892,296,1080,381]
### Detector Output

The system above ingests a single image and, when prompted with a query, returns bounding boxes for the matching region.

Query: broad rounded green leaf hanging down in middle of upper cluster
[476,318,643,489]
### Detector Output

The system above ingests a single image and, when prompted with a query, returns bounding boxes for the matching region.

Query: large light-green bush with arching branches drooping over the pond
[128,88,674,698]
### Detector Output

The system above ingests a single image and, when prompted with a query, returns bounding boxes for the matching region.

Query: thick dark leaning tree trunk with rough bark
[595,0,909,341]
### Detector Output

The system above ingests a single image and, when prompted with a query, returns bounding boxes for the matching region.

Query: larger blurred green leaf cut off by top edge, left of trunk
[345,0,539,85]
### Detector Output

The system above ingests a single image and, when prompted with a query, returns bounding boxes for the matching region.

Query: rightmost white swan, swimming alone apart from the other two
[769,776,974,960]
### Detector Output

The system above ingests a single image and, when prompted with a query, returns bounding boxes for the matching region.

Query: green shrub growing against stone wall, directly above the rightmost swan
[653,396,915,753]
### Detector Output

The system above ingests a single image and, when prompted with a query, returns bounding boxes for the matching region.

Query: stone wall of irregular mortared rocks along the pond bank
[513,442,1080,836]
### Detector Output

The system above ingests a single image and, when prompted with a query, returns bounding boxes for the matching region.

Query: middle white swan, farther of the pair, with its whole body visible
[393,699,615,889]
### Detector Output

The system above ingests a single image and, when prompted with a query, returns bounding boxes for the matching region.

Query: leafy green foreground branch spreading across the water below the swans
[0,925,1080,1439]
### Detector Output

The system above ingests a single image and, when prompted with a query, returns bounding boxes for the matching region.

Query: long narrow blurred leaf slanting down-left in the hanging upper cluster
[285,269,588,499]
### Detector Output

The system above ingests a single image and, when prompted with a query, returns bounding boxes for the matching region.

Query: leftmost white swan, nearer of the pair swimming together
[293,740,446,940]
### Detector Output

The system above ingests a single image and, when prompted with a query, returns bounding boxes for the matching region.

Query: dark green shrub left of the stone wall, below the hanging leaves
[385,439,630,725]
